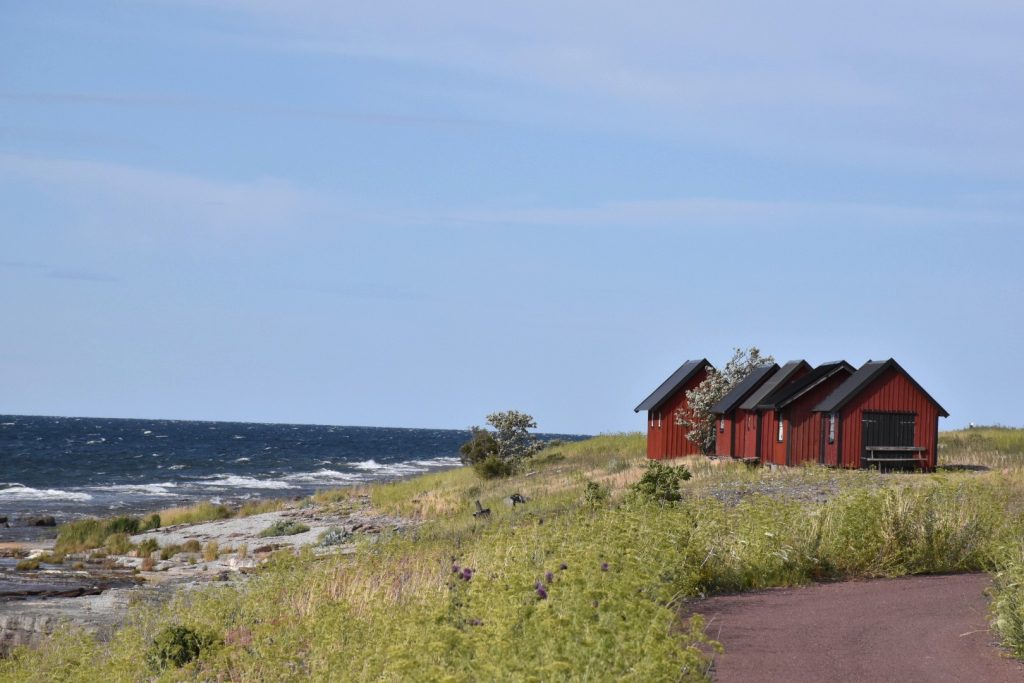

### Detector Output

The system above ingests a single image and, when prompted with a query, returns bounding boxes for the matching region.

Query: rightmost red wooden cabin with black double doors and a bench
[814,358,949,470]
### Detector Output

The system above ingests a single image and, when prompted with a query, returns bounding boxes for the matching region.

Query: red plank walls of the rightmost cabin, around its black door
[825,368,939,469]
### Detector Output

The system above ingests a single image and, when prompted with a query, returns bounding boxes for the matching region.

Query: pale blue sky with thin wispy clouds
[0,0,1024,433]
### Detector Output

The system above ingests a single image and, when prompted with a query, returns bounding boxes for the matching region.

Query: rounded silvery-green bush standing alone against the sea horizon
[459,411,542,479]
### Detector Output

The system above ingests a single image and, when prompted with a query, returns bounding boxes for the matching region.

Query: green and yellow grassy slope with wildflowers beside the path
[6,430,1024,681]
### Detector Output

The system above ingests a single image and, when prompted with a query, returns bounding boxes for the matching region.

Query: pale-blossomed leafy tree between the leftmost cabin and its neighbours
[676,346,775,455]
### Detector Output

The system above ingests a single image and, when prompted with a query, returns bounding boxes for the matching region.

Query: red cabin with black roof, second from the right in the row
[758,360,854,465]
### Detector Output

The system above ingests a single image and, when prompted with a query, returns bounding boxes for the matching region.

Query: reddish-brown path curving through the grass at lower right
[687,573,1024,683]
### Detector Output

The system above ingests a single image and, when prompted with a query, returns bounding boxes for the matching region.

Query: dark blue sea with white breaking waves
[0,415,584,542]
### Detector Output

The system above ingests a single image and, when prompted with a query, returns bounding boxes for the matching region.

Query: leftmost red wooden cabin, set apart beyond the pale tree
[633,358,713,460]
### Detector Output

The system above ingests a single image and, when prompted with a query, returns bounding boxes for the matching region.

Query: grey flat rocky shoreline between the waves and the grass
[0,498,415,656]
